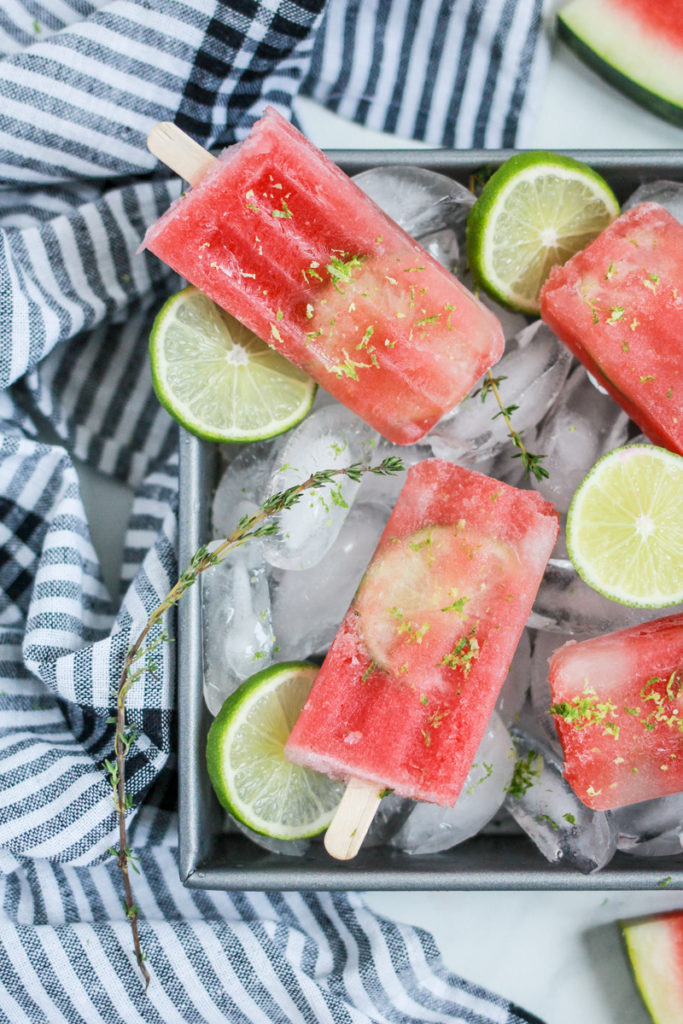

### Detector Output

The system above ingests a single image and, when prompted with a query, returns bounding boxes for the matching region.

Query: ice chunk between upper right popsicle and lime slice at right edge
[531,366,629,512]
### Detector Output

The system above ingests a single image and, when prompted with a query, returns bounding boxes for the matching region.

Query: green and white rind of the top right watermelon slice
[557,0,683,127]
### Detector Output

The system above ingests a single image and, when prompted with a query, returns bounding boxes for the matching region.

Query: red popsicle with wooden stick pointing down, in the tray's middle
[286,459,559,858]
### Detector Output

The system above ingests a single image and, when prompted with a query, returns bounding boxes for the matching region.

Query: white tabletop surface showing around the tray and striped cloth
[74,28,683,1024]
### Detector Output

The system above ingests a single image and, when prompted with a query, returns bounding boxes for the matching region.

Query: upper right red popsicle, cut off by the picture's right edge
[541,203,683,455]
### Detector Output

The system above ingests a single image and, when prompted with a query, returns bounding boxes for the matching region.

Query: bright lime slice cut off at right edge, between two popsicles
[567,444,683,608]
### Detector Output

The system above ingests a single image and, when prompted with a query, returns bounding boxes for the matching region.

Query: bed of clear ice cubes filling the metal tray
[203,167,683,871]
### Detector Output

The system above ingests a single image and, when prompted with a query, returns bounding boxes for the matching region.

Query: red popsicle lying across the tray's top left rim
[143,109,504,444]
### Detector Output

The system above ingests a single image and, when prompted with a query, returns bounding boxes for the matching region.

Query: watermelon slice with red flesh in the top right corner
[557,0,683,125]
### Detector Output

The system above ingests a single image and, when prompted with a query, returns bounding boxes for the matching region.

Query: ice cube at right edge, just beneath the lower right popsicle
[612,793,683,857]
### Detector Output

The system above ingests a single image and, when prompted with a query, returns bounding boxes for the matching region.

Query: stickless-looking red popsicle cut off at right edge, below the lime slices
[550,614,683,810]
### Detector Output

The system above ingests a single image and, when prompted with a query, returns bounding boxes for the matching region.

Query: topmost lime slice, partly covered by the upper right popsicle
[467,152,620,313]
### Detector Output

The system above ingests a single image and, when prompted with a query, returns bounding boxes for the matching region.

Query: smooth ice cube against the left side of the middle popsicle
[272,499,389,660]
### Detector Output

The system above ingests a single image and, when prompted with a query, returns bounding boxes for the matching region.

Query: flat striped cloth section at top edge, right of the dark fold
[303,0,548,150]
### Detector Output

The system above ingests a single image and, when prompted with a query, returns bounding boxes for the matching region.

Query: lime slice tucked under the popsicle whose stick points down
[202,662,344,840]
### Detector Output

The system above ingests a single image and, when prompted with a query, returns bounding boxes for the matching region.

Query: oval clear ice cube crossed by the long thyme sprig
[263,403,379,569]
